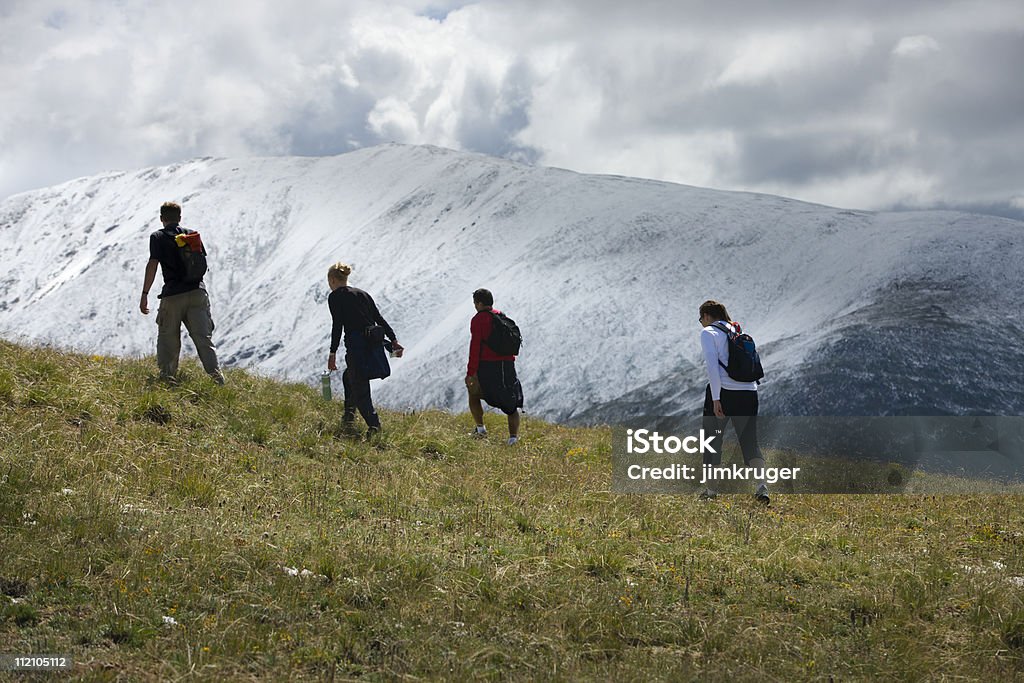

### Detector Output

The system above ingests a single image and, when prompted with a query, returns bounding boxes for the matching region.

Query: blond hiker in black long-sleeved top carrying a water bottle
[327,263,404,439]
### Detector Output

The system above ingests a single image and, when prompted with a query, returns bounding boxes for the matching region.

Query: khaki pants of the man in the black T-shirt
[157,290,221,378]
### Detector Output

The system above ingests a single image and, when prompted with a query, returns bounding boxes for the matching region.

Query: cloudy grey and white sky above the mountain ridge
[0,0,1024,218]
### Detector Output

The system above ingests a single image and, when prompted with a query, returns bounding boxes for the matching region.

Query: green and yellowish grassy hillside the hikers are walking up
[0,343,1024,681]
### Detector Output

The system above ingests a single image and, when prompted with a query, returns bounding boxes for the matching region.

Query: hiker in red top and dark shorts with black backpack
[466,289,522,445]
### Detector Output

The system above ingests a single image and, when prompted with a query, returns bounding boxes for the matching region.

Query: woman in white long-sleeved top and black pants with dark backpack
[697,300,771,505]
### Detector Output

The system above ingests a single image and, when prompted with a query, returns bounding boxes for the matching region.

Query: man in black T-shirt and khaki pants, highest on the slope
[138,202,224,384]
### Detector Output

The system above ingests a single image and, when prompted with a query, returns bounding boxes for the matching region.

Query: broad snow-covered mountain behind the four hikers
[0,144,1024,422]
